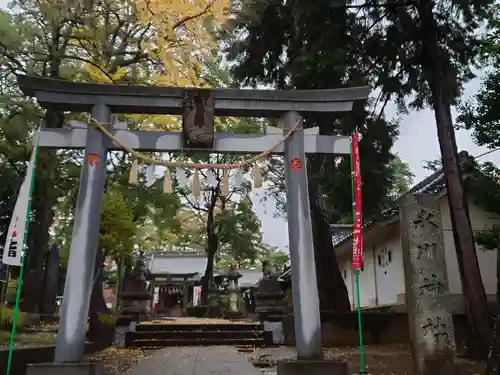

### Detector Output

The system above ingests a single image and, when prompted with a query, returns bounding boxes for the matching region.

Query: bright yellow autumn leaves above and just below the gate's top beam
[79,0,230,131]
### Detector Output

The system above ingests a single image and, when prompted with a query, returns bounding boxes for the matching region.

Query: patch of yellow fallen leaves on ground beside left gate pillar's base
[86,348,151,375]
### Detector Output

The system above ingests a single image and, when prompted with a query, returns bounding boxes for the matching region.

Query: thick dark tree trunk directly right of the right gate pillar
[309,169,351,311]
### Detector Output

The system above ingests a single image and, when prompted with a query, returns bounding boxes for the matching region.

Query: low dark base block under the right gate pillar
[278,359,349,375]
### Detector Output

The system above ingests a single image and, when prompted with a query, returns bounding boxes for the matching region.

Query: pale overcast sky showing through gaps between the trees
[0,0,500,253]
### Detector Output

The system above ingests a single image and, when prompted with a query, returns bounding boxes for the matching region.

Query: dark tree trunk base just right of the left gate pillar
[87,251,115,347]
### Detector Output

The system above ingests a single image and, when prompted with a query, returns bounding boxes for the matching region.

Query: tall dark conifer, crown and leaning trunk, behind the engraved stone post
[359,0,495,358]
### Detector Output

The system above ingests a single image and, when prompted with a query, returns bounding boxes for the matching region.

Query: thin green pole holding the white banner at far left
[5,135,38,375]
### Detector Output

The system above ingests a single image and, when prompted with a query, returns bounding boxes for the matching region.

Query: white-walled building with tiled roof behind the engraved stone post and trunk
[335,172,500,312]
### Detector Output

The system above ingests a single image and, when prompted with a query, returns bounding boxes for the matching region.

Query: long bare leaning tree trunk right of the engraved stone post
[417,1,491,359]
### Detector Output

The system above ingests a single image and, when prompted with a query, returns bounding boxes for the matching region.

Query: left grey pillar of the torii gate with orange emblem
[54,104,111,362]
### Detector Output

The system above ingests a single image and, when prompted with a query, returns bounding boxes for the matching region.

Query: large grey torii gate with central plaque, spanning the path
[18,76,370,372]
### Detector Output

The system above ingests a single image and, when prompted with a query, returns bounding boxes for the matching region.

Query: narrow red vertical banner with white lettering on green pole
[351,132,363,271]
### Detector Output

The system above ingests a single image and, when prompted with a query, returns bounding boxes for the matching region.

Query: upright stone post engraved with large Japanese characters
[400,194,457,375]
